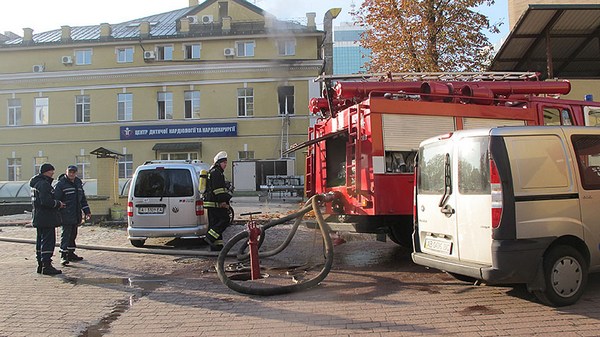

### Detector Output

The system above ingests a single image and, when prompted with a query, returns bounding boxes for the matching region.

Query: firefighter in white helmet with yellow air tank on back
[204,151,231,251]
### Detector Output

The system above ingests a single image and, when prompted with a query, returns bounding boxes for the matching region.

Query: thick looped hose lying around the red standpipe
[216,194,333,296]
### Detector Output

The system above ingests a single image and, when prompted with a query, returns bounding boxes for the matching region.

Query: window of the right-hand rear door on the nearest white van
[458,137,491,194]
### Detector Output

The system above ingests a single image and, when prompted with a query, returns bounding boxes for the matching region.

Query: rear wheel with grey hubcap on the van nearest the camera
[534,246,588,307]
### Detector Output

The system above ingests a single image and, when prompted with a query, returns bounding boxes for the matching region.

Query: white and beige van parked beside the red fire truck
[412,126,600,306]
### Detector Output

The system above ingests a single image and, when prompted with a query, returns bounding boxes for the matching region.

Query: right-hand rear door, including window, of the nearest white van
[454,135,492,265]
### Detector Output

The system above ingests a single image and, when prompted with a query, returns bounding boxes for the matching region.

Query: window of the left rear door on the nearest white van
[417,141,452,194]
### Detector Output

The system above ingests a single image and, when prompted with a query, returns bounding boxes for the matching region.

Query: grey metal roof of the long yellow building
[0,0,314,47]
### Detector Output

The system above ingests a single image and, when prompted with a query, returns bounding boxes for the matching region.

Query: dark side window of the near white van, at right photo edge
[571,135,600,190]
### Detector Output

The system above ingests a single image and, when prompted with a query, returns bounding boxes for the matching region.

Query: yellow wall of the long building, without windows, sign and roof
[0,1,322,180]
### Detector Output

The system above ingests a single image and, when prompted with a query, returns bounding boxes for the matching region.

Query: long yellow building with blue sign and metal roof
[0,0,324,189]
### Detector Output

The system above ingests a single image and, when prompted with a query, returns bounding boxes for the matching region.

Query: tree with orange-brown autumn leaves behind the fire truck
[354,0,500,72]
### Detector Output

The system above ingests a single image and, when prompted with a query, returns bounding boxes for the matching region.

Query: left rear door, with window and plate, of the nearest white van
[415,138,458,258]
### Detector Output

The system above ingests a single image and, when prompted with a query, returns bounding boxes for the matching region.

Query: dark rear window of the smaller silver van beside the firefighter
[133,169,194,197]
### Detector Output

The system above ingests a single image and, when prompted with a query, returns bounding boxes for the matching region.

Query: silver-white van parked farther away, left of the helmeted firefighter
[127,160,210,247]
